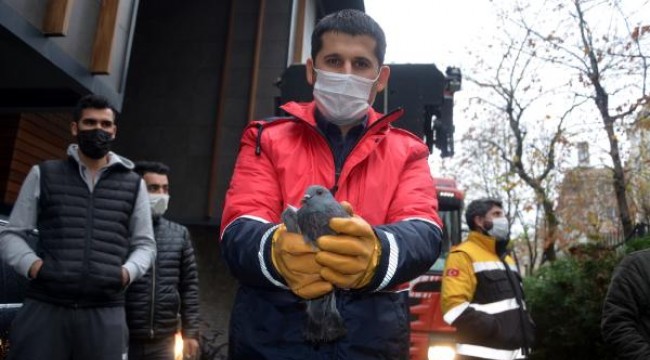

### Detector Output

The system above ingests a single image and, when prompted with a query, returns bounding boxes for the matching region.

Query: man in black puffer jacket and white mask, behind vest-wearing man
[126,161,199,360]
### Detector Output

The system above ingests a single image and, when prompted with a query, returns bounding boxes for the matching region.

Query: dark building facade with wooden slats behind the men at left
[0,0,364,348]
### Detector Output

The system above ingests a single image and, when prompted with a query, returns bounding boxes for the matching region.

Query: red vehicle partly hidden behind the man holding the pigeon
[409,178,464,360]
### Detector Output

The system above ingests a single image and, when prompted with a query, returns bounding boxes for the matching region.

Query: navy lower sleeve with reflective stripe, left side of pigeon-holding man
[221,218,286,288]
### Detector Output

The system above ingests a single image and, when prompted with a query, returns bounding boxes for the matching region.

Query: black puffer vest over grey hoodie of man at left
[27,158,140,307]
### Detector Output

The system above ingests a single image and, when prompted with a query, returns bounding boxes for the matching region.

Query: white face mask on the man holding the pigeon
[314,69,379,126]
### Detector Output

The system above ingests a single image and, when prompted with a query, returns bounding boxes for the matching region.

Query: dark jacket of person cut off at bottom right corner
[601,249,650,360]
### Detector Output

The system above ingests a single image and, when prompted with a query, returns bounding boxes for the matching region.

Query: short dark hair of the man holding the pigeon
[311,9,386,65]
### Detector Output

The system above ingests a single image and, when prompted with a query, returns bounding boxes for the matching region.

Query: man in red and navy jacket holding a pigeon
[221,10,442,360]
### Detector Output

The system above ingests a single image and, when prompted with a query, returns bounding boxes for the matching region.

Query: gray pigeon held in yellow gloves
[282,185,350,343]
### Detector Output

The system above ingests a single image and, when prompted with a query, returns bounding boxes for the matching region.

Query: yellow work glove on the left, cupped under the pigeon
[271,224,333,299]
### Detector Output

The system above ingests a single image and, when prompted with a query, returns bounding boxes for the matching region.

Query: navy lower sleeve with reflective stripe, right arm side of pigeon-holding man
[367,220,442,291]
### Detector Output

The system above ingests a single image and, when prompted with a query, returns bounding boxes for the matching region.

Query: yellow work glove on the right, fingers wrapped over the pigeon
[316,211,381,289]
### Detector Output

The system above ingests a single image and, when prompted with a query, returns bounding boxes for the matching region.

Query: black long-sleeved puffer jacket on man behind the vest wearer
[126,218,199,339]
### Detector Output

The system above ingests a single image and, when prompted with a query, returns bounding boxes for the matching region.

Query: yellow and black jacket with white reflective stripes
[442,231,534,360]
